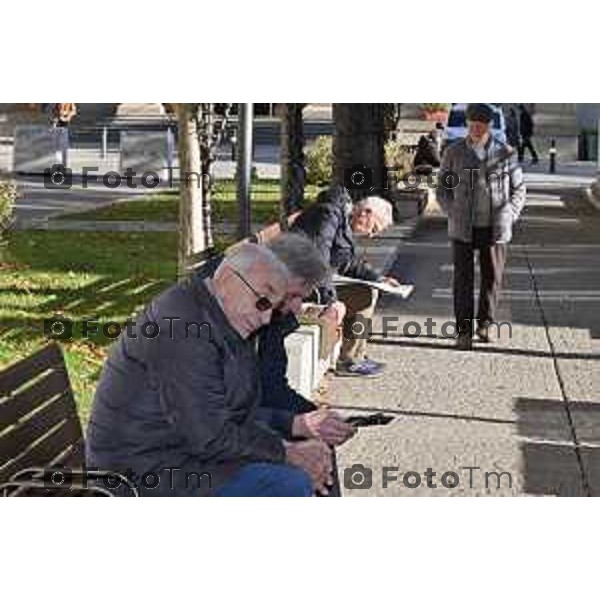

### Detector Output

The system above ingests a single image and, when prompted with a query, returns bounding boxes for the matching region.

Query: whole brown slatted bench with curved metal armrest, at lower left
[0,344,134,496]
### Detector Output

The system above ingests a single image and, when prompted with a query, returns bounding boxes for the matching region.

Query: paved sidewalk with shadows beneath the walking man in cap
[329,185,600,496]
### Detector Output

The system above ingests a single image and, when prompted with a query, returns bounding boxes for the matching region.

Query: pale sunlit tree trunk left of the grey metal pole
[176,104,206,279]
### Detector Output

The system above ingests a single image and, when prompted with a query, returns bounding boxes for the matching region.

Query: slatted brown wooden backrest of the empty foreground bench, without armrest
[0,344,85,483]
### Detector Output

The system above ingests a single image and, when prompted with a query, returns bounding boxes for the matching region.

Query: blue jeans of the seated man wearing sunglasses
[213,463,313,498]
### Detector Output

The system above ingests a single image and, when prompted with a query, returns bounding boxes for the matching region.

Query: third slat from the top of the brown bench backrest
[0,390,81,465]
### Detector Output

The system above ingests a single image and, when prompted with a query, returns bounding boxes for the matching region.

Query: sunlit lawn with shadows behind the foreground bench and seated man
[0,231,177,423]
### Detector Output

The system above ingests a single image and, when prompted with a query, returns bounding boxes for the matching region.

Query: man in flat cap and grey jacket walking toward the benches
[437,104,525,350]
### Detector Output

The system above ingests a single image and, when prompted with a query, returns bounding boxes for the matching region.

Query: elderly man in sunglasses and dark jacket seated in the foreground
[86,244,346,496]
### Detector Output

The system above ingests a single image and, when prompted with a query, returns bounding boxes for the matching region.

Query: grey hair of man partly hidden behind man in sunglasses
[267,233,328,286]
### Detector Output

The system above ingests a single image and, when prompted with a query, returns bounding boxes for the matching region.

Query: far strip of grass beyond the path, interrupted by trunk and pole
[61,180,319,223]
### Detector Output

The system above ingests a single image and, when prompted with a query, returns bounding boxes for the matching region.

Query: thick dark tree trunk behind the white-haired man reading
[333,104,385,200]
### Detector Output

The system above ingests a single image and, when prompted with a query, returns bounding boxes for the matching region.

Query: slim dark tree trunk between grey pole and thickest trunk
[280,104,306,230]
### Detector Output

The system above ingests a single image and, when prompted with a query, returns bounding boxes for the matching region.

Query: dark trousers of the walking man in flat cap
[452,227,506,333]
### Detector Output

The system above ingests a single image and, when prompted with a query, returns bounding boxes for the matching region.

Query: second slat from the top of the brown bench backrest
[0,369,69,431]
